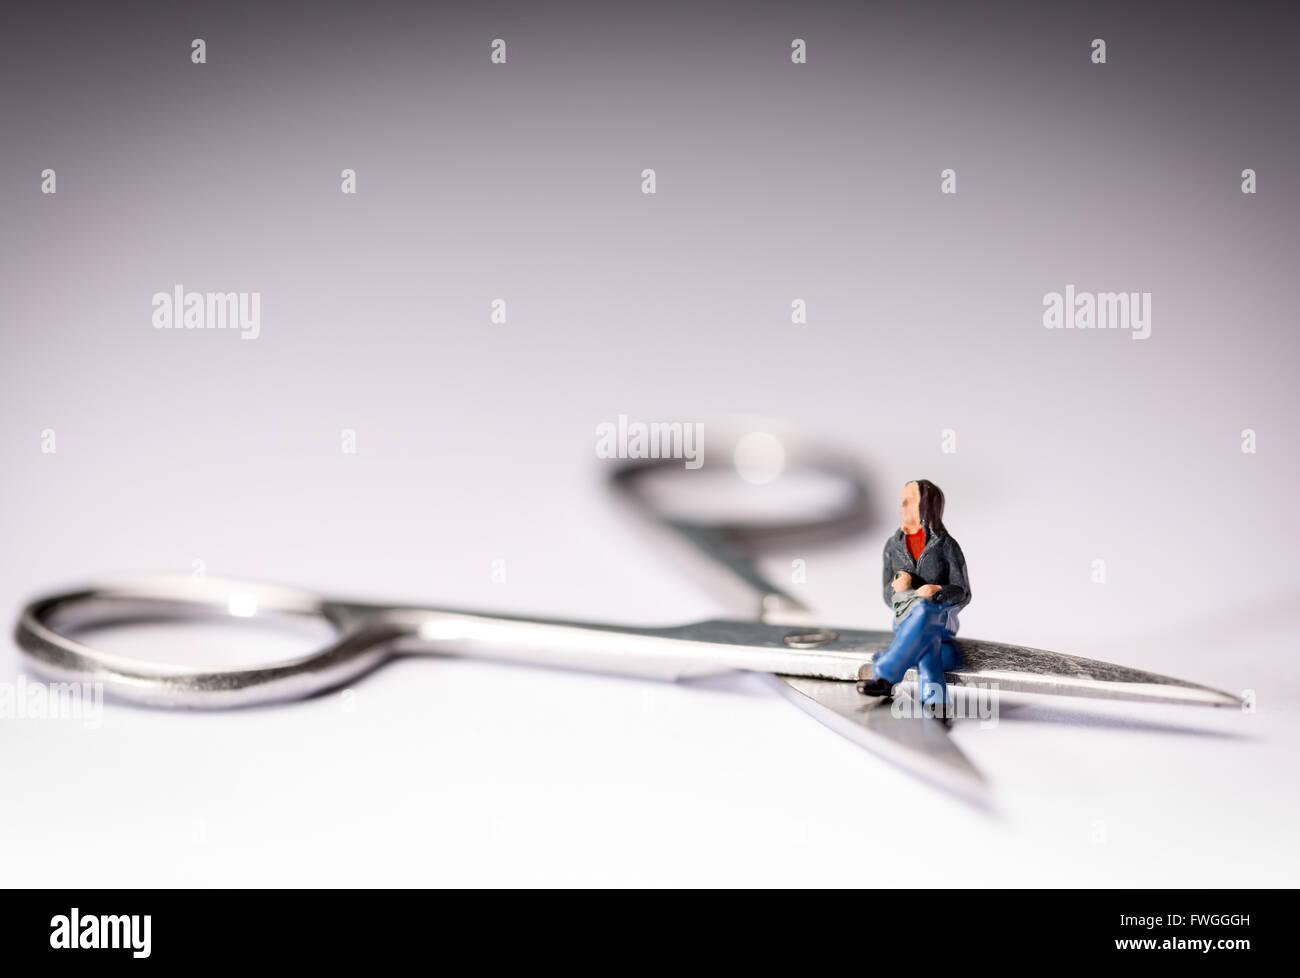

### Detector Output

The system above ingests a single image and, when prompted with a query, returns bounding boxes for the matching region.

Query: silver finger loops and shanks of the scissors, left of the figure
[16,423,888,707]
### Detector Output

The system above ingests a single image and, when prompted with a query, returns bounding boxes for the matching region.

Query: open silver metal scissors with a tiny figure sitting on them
[16,430,1242,799]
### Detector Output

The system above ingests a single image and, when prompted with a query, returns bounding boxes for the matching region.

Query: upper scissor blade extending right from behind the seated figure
[946,639,1242,706]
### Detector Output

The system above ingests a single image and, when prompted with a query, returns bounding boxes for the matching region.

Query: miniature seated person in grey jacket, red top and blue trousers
[858,479,971,713]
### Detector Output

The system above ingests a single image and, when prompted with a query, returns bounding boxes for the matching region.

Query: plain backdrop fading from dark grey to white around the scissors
[0,3,1300,886]
